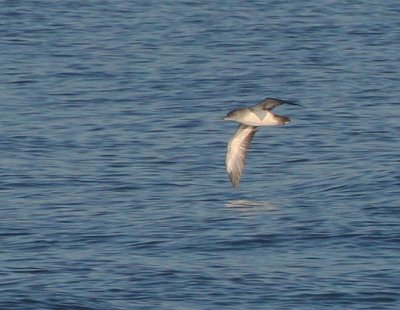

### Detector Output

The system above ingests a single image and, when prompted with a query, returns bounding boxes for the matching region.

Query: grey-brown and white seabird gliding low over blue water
[223,98,299,187]
